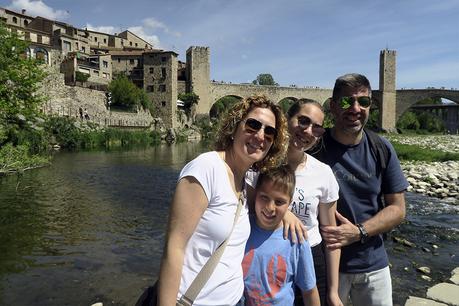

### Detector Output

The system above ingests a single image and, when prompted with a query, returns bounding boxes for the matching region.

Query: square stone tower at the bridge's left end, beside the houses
[186,46,212,115]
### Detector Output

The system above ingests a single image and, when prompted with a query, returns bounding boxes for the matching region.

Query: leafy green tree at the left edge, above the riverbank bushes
[0,22,45,145]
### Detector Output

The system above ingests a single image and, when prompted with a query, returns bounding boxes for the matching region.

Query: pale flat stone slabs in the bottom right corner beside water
[405,267,459,306]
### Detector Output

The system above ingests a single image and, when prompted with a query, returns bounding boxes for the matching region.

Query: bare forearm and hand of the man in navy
[321,191,405,249]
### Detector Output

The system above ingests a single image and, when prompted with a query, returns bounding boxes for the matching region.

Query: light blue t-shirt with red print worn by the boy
[242,215,316,305]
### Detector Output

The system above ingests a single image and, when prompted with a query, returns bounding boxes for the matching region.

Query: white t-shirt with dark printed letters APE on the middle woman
[289,153,339,247]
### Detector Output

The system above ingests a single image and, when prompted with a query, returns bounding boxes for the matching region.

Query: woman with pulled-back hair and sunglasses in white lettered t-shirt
[287,99,342,306]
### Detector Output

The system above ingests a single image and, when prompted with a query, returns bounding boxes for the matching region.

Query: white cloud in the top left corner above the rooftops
[8,0,70,21]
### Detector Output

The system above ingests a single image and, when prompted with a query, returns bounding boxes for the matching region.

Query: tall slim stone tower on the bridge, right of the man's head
[379,49,397,132]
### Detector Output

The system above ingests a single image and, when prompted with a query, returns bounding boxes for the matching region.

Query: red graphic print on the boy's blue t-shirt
[242,249,287,306]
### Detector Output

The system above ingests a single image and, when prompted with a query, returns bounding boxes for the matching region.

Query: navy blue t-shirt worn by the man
[324,133,409,273]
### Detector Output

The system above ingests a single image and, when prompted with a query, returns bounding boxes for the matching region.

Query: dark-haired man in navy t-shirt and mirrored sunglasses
[321,74,408,306]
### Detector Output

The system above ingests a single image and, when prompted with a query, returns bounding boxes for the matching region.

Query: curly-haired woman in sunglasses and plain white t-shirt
[158,96,288,306]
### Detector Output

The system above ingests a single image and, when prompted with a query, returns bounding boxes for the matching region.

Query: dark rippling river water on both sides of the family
[0,143,459,306]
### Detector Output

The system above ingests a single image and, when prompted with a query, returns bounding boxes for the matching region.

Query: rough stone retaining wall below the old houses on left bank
[39,68,154,128]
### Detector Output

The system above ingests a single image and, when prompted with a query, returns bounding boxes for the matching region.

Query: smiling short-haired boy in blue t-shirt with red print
[242,165,320,306]
